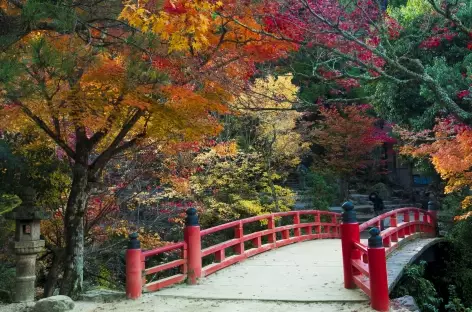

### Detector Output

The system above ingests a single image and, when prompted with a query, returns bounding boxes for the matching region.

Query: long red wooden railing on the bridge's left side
[126,208,341,299]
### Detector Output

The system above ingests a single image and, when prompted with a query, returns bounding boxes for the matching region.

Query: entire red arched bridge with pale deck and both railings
[126,202,438,311]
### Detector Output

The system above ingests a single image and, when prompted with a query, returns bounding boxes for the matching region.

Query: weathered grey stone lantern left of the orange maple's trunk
[6,188,50,302]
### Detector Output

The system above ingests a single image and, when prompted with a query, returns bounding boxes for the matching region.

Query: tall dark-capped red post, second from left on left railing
[184,208,202,285]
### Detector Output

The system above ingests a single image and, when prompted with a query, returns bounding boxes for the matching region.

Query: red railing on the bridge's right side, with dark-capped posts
[341,202,437,311]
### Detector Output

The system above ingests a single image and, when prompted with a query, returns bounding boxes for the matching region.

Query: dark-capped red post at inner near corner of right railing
[341,202,360,288]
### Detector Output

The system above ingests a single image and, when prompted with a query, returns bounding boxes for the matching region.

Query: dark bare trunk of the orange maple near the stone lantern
[60,163,90,299]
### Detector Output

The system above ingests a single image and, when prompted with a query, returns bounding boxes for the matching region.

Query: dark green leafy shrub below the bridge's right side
[393,261,442,312]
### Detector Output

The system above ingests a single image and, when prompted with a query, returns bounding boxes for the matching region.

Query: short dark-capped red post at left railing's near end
[126,233,144,299]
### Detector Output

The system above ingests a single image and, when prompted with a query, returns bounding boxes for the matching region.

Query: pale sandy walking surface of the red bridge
[155,239,368,302]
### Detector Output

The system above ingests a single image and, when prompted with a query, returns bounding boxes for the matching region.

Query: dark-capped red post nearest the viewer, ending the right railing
[367,228,390,311]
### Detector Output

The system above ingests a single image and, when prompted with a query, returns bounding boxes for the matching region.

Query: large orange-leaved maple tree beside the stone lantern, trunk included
[0,0,294,296]
